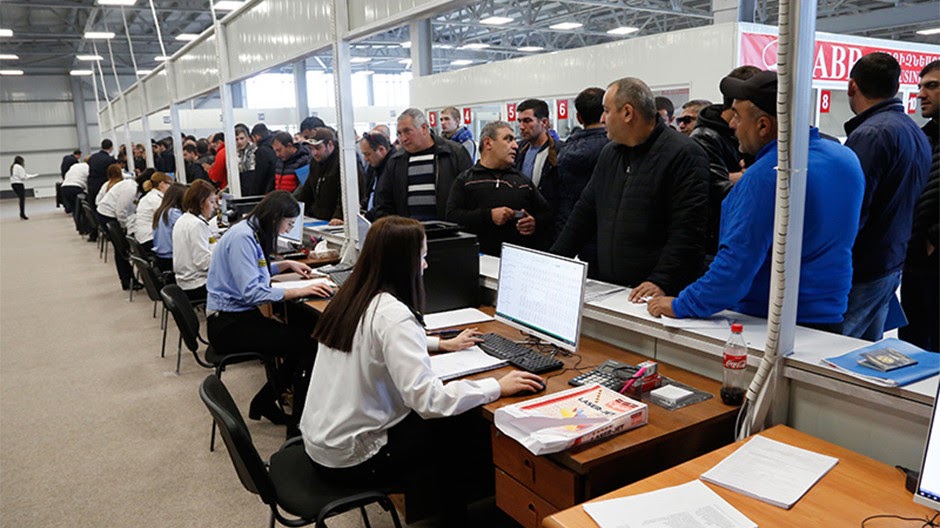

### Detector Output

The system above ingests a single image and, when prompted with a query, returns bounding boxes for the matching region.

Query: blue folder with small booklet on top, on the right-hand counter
[822,337,940,387]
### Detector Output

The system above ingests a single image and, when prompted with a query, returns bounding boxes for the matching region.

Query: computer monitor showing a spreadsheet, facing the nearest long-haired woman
[496,244,587,352]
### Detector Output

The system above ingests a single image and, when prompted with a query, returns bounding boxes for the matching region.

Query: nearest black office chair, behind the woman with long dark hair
[199,375,401,528]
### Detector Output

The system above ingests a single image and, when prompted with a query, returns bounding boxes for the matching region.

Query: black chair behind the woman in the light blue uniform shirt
[160,284,278,451]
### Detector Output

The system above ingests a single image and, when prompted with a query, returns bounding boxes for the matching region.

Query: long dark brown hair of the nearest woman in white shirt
[313,216,425,352]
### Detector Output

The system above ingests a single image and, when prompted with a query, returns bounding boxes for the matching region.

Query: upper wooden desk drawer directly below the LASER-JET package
[492,426,584,509]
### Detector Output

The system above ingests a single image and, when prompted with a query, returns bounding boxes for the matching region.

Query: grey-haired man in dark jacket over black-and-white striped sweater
[374,108,471,220]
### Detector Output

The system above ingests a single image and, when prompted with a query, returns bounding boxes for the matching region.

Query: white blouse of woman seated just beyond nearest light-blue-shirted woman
[173,213,215,290]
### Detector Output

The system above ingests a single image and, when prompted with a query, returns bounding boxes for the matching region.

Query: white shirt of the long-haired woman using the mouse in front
[300,293,500,468]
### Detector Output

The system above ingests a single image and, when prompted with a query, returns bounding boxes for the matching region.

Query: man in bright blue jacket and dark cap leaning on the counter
[647,71,865,331]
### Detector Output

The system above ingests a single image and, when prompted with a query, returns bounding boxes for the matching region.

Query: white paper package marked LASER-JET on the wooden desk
[495,384,649,455]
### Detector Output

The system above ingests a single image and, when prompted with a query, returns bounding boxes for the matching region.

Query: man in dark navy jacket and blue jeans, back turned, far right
[841,52,930,341]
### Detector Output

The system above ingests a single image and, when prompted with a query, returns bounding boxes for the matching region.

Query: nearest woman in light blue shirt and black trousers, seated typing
[207,192,332,424]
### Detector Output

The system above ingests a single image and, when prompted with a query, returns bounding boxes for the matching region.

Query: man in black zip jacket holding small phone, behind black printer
[447,121,552,256]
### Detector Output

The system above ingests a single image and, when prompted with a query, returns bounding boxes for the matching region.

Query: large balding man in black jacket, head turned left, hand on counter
[551,77,708,302]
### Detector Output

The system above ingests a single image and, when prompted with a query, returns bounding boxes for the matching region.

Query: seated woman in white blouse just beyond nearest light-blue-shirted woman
[173,180,218,301]
